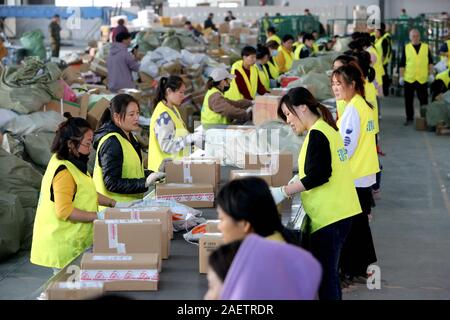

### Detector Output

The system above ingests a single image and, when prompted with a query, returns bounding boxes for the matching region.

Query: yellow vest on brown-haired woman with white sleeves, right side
[336,94,380,179]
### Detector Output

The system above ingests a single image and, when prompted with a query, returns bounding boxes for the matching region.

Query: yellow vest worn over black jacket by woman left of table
[94,132,145,202]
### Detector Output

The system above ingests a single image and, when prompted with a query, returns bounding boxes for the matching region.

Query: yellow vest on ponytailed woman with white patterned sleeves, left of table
[148,101,189,171]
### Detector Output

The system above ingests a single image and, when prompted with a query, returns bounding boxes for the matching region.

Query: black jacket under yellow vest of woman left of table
[94,122,150,194]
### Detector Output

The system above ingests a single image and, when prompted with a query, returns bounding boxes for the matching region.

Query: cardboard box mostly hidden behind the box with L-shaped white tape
[105,208,173,259]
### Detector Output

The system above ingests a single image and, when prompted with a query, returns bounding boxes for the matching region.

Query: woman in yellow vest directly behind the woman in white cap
[225,46,267,101]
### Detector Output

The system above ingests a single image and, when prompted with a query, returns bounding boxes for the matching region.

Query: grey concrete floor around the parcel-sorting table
[0,98,450,300]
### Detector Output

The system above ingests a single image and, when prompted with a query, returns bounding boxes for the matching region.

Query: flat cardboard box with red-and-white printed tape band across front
[80,253,160,291]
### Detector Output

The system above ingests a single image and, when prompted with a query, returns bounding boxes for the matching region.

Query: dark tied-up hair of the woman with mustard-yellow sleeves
[50,112,92,160]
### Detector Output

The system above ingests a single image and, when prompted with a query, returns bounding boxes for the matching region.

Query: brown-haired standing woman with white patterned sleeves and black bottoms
[331,64,380,283]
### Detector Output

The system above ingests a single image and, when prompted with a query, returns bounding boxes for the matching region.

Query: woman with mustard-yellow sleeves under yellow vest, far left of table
[30,114,115,273]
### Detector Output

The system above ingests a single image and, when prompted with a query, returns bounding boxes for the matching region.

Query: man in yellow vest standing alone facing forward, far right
[399,29,434,125]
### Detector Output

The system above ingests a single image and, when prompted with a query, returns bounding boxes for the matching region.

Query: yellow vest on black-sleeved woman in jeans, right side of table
[298,119,361,232]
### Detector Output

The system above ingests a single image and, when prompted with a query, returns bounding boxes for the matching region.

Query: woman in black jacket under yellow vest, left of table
[94,94,164,208]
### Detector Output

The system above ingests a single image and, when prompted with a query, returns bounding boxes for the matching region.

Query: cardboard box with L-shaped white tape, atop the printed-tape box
[93,219,162,270]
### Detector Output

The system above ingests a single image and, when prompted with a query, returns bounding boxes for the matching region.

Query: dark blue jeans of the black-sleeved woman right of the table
[310,217,351,300]
